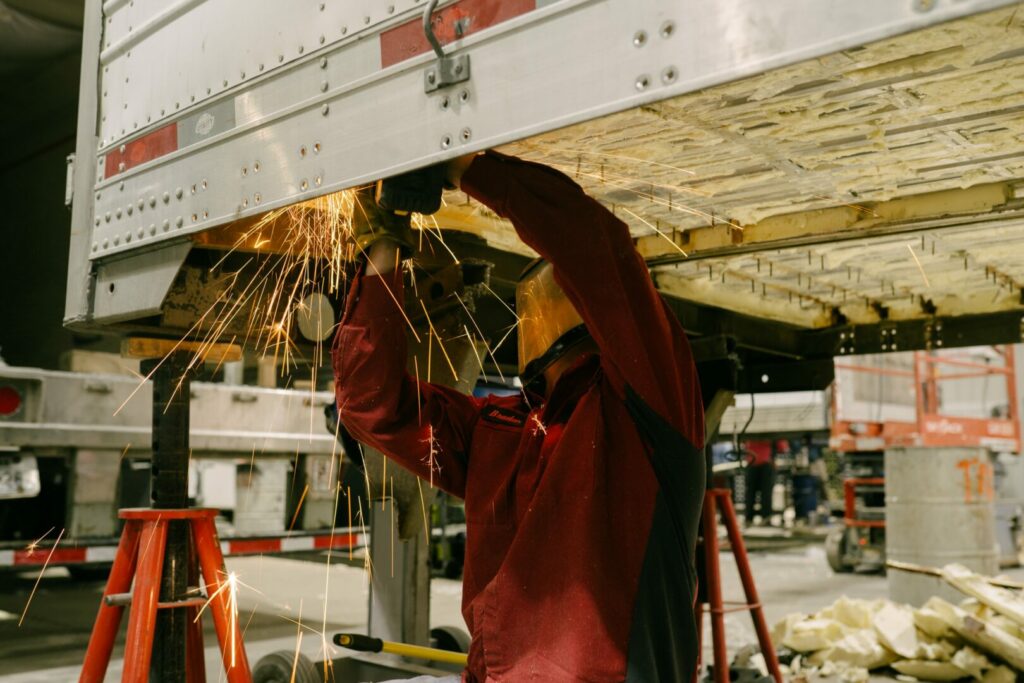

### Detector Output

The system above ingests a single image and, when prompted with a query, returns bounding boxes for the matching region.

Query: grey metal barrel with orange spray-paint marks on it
[885,447,999,605]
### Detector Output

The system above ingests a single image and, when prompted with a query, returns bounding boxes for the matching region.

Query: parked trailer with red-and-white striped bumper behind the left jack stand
[0,366,364,569]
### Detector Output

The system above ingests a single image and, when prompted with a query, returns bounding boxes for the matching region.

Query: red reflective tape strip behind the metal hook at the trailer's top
[381,0,537,69]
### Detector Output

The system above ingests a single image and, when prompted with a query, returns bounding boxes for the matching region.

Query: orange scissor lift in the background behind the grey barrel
[825,345,1021,571]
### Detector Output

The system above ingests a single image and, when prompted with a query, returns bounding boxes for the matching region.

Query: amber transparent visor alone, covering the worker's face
[515,261,583,376]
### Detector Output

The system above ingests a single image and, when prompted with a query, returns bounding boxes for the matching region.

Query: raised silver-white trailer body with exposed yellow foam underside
[66,0,1024,355]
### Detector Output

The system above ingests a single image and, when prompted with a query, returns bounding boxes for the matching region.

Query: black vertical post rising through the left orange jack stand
[143,351,191,683]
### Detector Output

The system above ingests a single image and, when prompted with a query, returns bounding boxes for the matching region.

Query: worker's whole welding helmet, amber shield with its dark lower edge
[515,259,588,385]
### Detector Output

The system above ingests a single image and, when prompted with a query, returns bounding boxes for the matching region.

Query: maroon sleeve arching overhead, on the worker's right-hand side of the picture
[462,153,703,447]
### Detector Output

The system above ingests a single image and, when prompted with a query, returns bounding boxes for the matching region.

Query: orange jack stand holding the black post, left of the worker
[79,508,252,683]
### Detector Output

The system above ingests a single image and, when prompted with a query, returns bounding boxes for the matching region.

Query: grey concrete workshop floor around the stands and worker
[0,544,1024,683]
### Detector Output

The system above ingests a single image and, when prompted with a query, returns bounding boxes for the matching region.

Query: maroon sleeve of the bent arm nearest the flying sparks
[332,271,479,498]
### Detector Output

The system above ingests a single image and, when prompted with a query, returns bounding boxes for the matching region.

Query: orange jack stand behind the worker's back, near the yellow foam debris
[697,488,782,683]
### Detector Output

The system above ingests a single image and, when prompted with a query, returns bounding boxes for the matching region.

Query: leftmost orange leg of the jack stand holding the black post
[78,521,141,683]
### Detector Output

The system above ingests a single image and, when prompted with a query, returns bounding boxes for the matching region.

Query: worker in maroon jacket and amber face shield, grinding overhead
[333,153,705,682]
